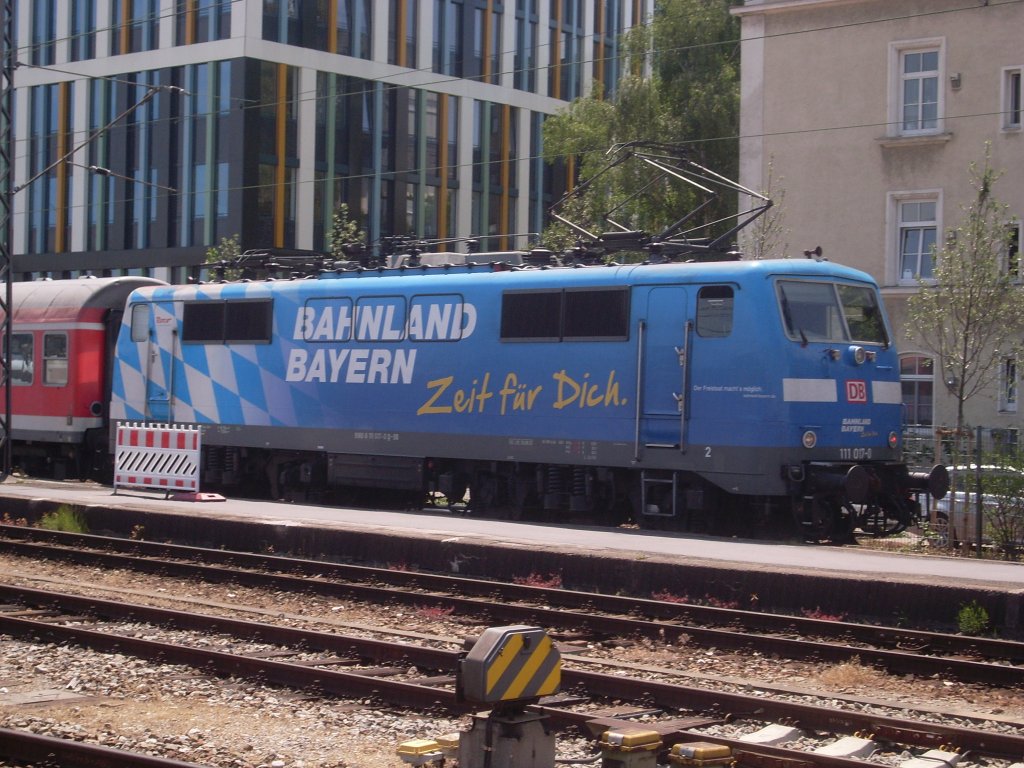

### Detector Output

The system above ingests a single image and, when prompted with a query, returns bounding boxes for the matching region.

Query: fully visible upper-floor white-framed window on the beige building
[889,39,945,136]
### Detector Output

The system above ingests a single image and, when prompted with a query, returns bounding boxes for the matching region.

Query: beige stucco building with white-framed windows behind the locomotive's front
[733,0,1024,448]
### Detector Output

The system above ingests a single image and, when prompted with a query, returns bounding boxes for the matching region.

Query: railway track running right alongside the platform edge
[0,525,1024,688]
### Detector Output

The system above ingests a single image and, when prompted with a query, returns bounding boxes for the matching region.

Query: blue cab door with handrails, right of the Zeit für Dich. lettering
[638,286,691,451]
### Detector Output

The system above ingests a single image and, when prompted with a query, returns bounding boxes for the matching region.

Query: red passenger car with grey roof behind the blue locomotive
[0,278,164,478]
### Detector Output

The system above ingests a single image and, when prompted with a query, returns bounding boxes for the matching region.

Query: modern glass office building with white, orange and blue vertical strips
[12,0,653,282]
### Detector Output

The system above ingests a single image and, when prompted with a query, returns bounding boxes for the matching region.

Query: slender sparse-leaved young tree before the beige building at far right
[906,145,1024,438]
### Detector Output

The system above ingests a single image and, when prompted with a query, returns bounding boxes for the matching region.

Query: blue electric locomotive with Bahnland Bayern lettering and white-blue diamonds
[111,259,941,539]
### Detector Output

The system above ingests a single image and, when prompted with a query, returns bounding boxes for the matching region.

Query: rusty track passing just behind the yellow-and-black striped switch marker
[0,587,1024,768]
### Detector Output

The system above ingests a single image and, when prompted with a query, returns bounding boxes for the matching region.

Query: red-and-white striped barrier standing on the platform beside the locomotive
[114,423,201,495]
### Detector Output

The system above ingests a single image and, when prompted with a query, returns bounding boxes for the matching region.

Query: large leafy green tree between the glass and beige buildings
[544,0,739,244]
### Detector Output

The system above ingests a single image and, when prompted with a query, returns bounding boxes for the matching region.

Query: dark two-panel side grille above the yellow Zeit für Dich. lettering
[502,288,630,341]
